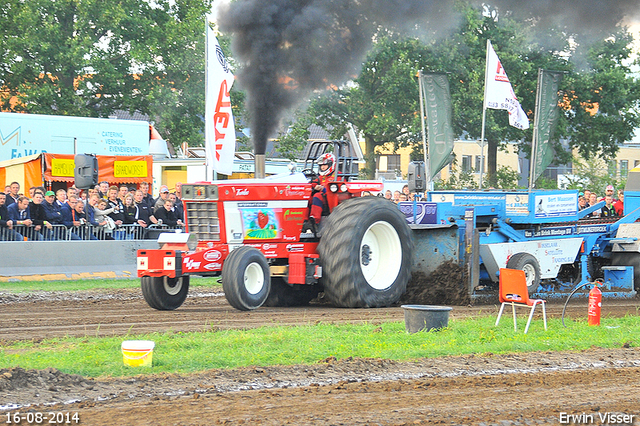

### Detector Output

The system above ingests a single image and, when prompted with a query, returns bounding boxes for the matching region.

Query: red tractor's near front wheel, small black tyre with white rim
[222,246,271,311]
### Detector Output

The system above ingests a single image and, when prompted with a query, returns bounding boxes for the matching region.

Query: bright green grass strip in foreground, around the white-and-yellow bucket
[0,316,640,377]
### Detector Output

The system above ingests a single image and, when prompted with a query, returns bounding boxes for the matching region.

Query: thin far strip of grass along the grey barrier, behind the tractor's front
[0,277,222,293]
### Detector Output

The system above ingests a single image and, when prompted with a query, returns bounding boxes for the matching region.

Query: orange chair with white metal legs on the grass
[496,268,547,334]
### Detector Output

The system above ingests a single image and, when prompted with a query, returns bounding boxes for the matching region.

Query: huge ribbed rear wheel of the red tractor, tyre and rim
[318,197,413,308]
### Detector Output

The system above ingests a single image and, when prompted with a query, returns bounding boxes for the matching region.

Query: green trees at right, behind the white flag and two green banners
[292,3,640,186]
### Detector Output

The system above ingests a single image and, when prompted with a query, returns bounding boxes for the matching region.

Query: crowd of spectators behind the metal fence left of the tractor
[0,182,184,241]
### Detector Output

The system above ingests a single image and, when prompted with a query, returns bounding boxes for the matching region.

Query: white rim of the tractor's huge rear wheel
[360,221,402,290]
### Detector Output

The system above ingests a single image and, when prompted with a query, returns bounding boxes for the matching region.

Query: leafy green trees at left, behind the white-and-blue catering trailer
[0,0,211,148]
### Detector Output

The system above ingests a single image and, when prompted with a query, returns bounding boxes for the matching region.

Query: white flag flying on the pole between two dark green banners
[484,42,529,130]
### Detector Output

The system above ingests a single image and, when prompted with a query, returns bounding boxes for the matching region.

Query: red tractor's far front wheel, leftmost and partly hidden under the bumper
[140,276,189,311]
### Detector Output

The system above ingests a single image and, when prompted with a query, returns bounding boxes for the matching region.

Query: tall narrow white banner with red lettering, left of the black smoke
[204,22,236,178]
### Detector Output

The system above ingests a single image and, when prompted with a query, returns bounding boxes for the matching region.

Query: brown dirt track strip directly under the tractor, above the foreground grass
[0,287,640,342]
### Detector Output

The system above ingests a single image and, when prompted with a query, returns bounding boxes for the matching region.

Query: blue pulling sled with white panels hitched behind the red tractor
[399,169,640,299]
